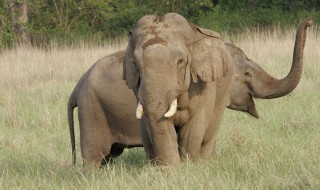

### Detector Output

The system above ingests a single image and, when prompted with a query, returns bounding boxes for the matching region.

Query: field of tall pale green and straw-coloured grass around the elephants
[0,26,320,190]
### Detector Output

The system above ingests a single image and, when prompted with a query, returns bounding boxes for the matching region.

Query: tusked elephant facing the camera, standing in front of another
[124,13,233,165]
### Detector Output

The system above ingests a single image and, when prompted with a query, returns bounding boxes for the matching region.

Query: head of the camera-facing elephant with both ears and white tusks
[124,13,227,118]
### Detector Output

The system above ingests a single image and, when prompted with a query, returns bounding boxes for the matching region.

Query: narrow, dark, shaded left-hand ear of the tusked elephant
[122,46,139,89]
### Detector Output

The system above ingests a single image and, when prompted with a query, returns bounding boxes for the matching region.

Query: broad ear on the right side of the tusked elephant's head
[190,27,230,82]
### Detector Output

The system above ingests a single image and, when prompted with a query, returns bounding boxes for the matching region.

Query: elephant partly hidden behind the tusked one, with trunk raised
[68,15,312,166]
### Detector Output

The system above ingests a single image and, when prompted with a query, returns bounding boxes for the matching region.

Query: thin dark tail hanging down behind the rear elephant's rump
[68,95,77,165]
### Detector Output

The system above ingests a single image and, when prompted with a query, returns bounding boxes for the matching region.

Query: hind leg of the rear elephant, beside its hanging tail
[78,95,112,167]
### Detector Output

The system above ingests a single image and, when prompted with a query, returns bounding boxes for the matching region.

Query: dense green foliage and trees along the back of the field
[0,0,320,47]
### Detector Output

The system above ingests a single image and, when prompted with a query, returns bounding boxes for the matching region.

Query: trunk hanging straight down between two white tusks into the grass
[138,81,180,165]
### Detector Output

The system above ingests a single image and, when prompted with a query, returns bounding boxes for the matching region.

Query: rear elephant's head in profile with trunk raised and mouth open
[227,18,312,118]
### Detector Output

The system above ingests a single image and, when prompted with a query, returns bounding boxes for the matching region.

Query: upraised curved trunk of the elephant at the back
[251,18,312,99]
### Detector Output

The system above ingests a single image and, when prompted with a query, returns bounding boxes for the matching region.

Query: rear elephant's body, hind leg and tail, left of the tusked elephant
[68,51,142,166]
